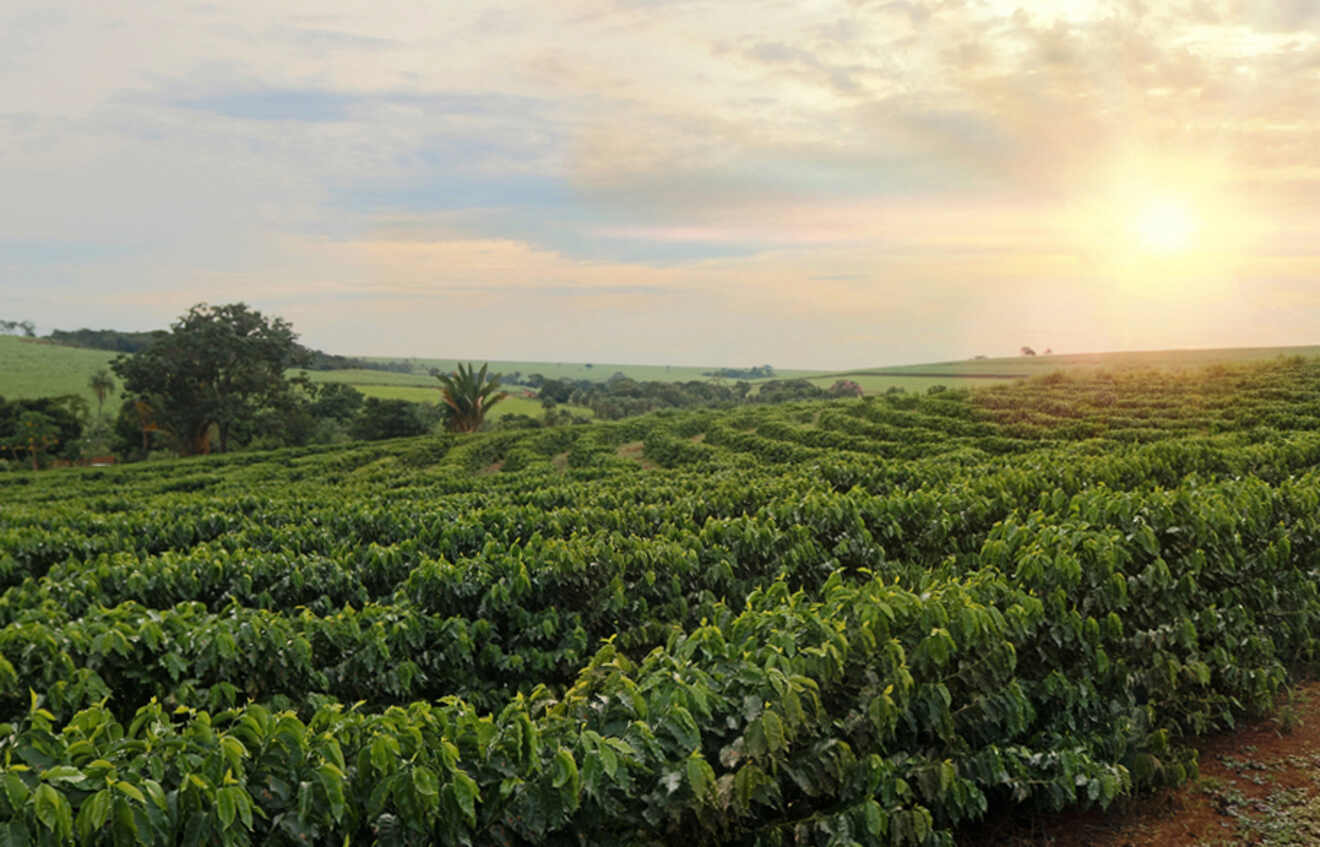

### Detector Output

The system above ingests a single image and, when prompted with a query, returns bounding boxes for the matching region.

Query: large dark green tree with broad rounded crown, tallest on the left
[111,303,304,455]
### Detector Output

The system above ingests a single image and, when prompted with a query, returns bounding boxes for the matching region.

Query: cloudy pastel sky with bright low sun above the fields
[0,0,1320,368]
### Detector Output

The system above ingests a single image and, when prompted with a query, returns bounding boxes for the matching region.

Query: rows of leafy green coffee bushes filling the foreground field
[0,360,1320,846]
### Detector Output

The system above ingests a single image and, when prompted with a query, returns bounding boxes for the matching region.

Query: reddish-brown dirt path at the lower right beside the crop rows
[960,682,1320,847]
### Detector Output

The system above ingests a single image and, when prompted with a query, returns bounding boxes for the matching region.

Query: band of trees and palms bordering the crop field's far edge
[0,302,881,468]
